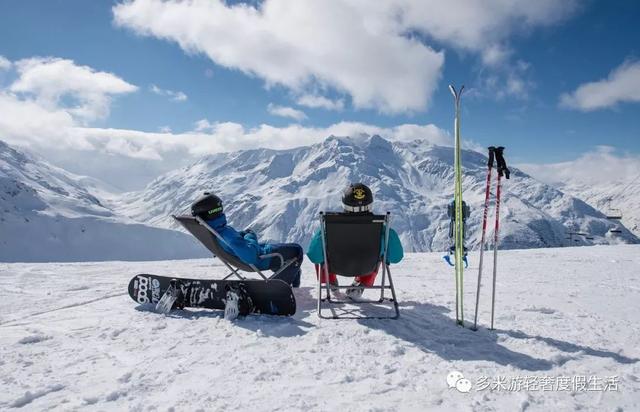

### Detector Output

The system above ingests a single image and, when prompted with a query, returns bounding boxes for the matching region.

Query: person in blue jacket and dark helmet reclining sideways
[193,193,304,288]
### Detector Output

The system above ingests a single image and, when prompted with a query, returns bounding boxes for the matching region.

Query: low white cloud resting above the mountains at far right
[518,146,640,186]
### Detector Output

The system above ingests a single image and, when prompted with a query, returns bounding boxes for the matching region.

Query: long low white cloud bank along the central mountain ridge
[62,122,452,190]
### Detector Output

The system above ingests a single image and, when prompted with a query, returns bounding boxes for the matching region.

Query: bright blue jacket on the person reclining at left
[207,213,271,270]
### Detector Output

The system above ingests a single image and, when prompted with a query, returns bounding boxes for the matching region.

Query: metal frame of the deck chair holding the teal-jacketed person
[317,212,400,319]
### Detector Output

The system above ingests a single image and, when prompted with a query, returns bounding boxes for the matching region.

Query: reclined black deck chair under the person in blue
[171,215,295,281]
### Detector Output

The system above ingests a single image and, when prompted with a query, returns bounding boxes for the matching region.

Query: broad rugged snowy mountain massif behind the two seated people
[116,136,638,251]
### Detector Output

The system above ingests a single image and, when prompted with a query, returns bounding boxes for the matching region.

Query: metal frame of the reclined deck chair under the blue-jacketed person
[171,215,296,282]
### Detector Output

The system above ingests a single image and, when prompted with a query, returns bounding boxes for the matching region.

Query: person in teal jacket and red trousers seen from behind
[307,183,404,299]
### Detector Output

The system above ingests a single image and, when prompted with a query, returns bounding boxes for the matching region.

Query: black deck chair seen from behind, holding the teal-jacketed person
[318,212,400,319]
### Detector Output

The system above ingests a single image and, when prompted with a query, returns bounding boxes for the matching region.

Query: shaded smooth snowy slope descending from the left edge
[0,141,205,262]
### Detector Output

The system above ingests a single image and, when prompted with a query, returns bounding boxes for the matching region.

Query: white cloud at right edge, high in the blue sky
[560,61,640,112]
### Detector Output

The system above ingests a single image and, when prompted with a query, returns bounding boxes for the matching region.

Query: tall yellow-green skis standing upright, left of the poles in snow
[449,85,464,326]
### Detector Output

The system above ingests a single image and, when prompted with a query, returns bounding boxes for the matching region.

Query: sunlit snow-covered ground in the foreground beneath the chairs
[0,246,640,411]
